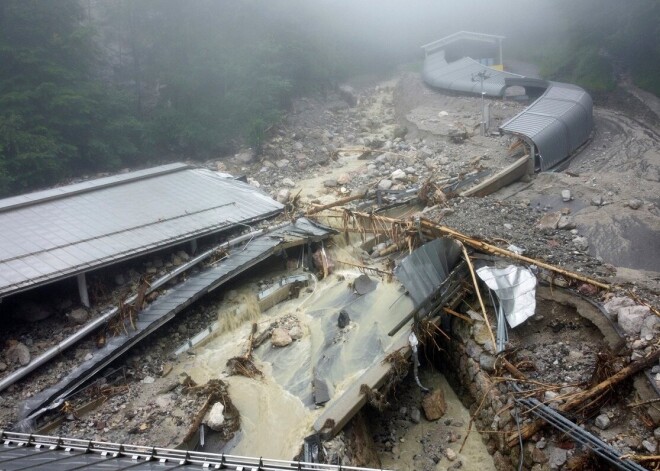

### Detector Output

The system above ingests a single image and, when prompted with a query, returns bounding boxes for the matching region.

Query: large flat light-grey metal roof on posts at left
[0,164,283,296]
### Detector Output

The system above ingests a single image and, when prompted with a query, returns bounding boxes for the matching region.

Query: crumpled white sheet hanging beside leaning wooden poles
[477,265,536,328]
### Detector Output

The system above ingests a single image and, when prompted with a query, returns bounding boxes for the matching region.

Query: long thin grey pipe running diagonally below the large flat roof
[0,222,290,391]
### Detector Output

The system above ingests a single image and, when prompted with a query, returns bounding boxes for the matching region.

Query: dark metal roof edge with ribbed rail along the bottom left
[0,431,386,471]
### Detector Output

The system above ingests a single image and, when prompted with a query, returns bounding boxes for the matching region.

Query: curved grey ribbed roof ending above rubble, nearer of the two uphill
[500,79,593,170]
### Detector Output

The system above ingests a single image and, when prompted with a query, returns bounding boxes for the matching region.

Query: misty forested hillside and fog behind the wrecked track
[0,0,660,196]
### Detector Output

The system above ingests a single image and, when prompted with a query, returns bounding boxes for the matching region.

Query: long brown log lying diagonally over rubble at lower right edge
[508,349,660,446]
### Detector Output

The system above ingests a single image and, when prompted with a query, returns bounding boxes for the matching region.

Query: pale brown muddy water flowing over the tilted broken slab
[175,249,496,469]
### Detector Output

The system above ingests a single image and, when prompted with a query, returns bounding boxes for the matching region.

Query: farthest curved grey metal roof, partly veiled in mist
[422,51,521,97]
